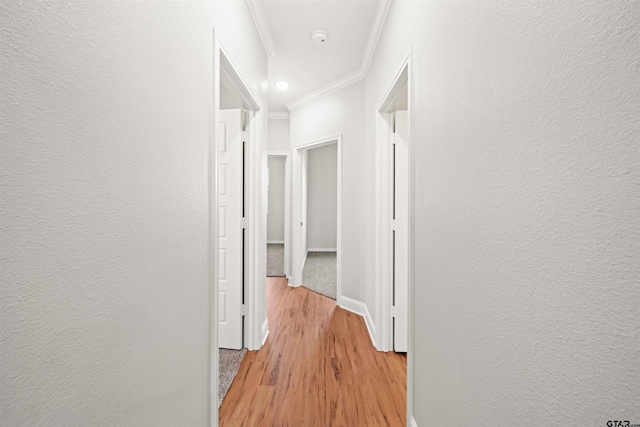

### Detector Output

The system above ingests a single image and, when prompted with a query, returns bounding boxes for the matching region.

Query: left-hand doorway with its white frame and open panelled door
[208,30,267,418]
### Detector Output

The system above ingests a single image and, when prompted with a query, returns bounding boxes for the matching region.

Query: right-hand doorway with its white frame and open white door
[375,49,414,420]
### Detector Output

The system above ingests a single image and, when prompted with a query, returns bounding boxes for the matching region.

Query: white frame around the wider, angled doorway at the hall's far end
[289,133,342,305]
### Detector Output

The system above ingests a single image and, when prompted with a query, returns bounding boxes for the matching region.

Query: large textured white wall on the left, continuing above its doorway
[0,0,267,426]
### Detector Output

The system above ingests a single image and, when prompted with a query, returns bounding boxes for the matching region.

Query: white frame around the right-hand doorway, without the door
[375,47,415,420]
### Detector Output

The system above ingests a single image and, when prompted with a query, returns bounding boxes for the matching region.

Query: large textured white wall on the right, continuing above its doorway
[368,1,640,426]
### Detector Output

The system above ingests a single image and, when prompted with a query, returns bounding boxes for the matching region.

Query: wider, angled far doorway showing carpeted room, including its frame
[290,135,342,305]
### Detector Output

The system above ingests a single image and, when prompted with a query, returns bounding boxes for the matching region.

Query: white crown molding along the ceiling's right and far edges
[286,0,393,111]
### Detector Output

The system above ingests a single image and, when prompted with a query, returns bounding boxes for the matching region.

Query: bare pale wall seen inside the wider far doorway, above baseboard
[307,143,338,251]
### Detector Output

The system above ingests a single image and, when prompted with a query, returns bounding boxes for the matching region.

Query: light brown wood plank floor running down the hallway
[219,277,407,427]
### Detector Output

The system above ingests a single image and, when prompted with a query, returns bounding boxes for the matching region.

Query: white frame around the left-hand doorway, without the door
[207,28,268,426]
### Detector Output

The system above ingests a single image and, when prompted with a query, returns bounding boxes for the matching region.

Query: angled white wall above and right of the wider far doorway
[290,81,375,304]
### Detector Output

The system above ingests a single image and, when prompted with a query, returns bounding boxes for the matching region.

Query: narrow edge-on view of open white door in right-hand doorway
[393,110,409,352]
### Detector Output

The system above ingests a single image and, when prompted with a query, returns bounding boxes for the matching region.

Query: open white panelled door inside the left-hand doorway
[218,109,244,350]
